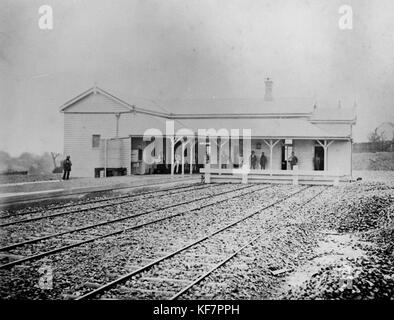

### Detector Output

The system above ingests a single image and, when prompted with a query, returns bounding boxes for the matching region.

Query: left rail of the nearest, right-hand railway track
[75,186,310,300]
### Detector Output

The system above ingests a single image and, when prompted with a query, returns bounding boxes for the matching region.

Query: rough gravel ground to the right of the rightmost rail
[175,183,394,299]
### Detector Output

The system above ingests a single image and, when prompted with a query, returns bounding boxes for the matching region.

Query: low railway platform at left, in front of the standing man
[0,175,201,206]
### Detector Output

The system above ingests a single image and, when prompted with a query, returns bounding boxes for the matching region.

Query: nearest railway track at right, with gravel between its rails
[76,187,327,300]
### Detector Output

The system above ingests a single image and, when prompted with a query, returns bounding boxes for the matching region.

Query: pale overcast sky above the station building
[0,0,394,155]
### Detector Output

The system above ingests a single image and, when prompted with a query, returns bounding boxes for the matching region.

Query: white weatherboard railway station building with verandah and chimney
[60,79,356,182]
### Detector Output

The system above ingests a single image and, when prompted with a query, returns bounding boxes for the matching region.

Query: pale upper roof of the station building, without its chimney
[60,86,356,123]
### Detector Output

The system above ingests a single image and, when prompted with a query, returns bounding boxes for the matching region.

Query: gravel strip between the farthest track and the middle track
[2,185,246,255]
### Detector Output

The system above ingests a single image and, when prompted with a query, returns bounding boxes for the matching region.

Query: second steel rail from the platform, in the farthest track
[0,181,212,227]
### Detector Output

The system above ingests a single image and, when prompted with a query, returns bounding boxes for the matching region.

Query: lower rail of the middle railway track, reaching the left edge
[0,182,268,269]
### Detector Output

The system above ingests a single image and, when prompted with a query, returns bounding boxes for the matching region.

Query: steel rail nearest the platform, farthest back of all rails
[0,183,202,220]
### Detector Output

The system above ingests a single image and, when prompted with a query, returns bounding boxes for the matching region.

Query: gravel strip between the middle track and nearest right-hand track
[0,185,290,298]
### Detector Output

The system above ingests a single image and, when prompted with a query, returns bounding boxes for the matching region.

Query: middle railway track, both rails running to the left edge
[0,185,269,269]
